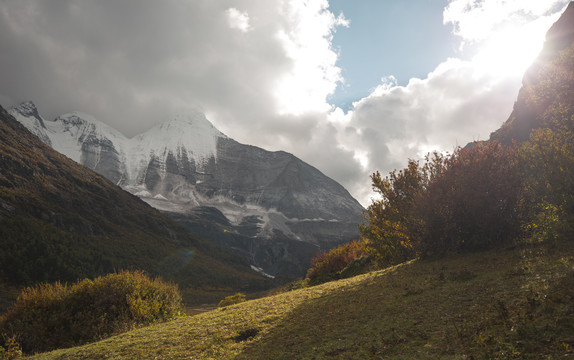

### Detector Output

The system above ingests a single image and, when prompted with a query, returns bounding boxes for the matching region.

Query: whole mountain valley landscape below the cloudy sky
[0,2,574,360]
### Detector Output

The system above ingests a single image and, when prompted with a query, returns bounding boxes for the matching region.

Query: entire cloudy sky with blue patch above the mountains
[0,0,568,206]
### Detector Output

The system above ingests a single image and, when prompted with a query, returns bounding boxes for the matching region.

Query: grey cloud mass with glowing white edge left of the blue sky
[0,0,344,138]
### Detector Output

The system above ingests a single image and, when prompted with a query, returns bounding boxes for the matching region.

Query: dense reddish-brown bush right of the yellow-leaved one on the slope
[417,142,524,255]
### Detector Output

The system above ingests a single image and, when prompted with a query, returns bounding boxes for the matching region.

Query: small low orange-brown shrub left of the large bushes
[307,240,369,285]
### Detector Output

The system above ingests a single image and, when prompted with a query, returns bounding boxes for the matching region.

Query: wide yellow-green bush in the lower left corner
[0,271,182,353]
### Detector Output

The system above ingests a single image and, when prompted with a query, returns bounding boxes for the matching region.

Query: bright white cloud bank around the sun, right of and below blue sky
[324,0,568,205]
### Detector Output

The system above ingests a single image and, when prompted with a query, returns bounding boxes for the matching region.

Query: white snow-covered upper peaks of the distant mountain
[11,102,227,186]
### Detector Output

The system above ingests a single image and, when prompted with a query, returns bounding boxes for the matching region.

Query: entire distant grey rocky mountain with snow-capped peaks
[10,102,362,275]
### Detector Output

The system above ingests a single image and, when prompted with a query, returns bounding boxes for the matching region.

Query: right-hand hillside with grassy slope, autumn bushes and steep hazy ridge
[4,4,574,359]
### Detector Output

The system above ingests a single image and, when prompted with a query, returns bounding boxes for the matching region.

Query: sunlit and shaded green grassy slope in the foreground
[34,239,574,359]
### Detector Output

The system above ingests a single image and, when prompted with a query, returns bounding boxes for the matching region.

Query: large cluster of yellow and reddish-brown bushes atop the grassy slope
[360,142,523,265]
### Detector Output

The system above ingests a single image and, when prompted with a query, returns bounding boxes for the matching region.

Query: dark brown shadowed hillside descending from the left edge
[0,108,274,310]
